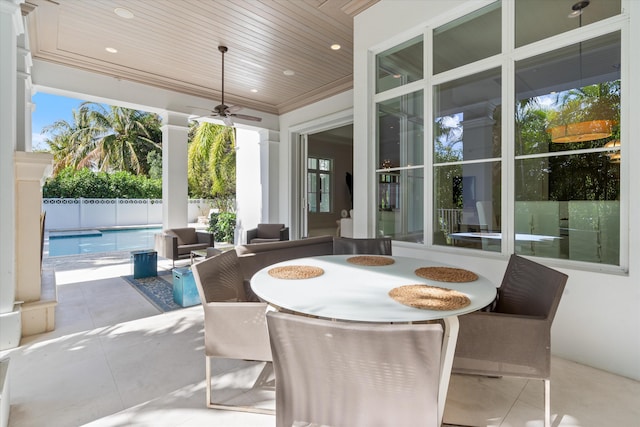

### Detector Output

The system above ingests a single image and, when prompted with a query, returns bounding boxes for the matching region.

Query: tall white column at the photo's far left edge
[0,0,24,350]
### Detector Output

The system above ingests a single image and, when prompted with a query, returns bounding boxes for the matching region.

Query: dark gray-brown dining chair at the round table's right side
[452,255,568,427]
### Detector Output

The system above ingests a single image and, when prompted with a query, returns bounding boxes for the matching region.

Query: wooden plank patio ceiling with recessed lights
[23,0,378,114]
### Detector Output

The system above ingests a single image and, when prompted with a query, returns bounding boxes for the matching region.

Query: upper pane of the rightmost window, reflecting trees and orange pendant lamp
[515,33,620,155]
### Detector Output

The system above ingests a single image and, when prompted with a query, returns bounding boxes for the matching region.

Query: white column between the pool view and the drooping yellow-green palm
[162,112,189,229]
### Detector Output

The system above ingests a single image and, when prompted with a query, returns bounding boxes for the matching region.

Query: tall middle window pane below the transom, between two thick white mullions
[433,69,502,251]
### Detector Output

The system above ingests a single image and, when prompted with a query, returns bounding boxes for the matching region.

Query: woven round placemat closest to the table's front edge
[389,285,471,310]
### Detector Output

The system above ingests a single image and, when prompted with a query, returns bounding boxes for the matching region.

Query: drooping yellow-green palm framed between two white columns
[188,122,236,198]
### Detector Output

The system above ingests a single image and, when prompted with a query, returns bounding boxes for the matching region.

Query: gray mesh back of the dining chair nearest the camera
[267,312,443,427]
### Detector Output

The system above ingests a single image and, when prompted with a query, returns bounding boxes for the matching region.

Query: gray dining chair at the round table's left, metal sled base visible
[192,250,273,414]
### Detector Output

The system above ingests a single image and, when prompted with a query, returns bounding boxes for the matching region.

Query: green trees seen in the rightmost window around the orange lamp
[516,80,620,206]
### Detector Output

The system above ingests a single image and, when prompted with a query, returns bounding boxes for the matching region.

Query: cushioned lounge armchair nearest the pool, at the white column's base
[154,227,215,266]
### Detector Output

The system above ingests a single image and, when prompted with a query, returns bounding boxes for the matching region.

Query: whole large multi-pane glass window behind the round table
[375,0,629,265]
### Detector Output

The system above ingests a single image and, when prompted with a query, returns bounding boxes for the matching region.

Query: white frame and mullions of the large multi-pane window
[368,0,631,274]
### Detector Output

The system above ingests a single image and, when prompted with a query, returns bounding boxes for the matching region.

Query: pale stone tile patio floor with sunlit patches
[0,253,640,427]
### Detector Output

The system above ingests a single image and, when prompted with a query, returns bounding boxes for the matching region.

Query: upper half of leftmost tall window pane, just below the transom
[378,91,424,169]
